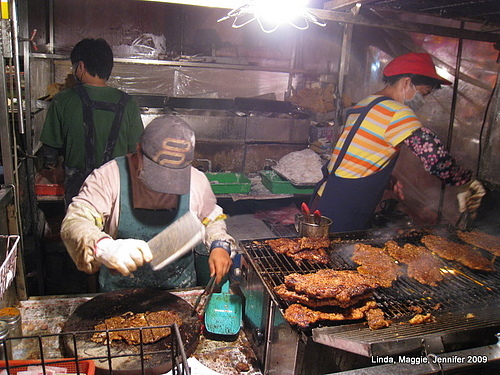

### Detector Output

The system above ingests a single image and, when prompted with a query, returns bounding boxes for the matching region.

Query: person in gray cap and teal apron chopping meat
[61,116,235,292]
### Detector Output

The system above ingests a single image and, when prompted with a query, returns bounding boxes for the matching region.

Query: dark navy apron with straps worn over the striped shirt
[310,97,399,232]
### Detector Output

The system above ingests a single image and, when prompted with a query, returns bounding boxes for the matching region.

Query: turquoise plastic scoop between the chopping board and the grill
[205,279,242,340]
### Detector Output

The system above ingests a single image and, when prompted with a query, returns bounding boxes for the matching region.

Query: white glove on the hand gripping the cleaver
[95,237,153,276]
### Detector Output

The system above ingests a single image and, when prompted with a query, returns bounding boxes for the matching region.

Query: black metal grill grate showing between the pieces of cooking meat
[241,227,500,319]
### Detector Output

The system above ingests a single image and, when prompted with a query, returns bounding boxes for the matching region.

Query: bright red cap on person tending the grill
[384,52,451,85]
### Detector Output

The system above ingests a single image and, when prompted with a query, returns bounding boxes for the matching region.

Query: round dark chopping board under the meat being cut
[61,289,201,375]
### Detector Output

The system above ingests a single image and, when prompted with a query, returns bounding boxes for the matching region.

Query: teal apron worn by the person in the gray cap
[99,156,196,292]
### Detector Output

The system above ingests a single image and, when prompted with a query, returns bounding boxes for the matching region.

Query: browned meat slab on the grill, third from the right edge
[384,241,443,286]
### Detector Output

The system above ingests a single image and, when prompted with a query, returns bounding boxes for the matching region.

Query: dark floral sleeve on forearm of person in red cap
[404,127,472,186]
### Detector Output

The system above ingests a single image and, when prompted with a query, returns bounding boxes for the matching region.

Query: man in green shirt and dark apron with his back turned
[40,39,144,206]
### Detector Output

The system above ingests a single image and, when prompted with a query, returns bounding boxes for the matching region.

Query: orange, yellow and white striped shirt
[328,95,422,178]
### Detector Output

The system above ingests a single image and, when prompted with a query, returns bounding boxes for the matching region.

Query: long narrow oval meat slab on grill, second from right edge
[421,234,494,271]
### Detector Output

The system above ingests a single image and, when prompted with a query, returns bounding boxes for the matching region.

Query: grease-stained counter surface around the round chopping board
[13,288,260,375]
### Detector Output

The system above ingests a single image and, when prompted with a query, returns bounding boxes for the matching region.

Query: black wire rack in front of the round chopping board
[0,323,191,375]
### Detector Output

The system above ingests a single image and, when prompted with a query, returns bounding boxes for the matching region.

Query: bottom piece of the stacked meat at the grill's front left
[284,301,377,328]
